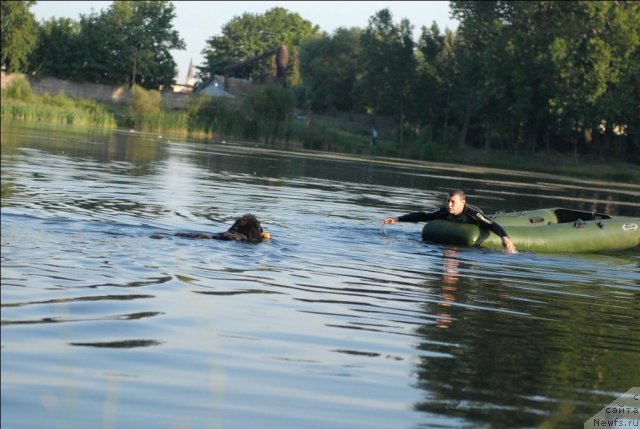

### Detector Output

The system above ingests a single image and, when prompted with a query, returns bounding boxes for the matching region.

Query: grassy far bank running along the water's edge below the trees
[2,75,640,184]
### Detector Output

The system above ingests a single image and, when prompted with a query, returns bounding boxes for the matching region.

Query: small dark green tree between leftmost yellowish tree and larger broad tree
[29,18,80,79]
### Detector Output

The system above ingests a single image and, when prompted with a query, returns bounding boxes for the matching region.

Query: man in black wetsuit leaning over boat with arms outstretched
[382,189,516,253]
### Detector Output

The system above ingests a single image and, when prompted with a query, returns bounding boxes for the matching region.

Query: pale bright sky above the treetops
[31,0,458,83]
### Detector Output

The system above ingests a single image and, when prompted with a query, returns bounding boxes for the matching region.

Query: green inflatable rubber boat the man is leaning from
[422,208,640,253]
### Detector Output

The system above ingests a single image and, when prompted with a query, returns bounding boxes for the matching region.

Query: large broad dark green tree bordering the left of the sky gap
[73,1,185,89]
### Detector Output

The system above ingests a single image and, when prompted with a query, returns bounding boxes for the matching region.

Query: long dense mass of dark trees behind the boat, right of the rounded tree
[300,1,640,162]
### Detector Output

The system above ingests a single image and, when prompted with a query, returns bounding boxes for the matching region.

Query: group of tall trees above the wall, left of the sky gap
[2,1,185,89]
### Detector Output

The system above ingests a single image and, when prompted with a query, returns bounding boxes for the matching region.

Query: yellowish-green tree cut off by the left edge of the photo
[0,0,37,72]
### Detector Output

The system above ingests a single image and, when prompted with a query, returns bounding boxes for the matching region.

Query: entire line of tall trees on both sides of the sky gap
[1,1,640,163]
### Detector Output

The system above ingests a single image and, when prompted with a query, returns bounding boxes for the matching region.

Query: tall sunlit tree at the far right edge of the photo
[548,2,640,154]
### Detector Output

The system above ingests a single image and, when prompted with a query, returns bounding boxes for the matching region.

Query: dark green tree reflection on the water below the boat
[416,249,640,427]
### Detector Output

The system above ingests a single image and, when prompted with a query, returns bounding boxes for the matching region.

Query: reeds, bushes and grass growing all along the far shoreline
[1,78,640,184]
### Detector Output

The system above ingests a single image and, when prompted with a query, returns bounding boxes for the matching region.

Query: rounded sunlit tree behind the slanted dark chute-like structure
[197,7,319,85]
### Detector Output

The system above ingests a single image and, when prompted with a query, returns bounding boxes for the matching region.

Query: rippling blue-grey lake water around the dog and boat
[1,123,640,429]
